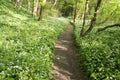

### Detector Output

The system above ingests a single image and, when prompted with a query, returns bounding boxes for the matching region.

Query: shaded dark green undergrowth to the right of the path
[74,24,120,80]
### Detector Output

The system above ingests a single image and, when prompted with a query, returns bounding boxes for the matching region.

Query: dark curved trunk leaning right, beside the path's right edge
[82,0,102,37]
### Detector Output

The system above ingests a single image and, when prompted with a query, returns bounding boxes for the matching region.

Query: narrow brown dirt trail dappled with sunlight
[52,25,89,80]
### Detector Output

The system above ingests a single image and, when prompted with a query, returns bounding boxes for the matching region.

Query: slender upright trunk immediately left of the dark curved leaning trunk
[80,0,89,36]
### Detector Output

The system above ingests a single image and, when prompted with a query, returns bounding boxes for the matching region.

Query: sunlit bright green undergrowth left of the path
[0,0,67,80]
